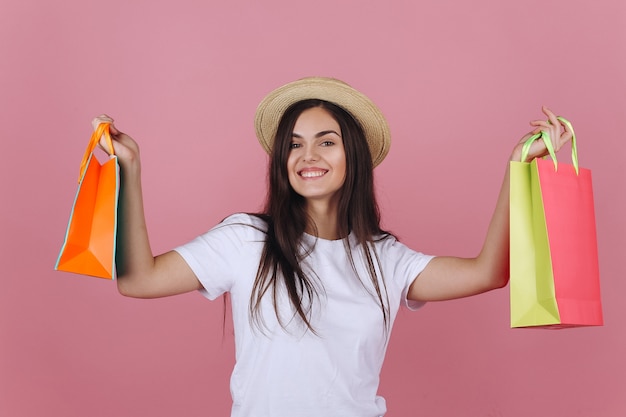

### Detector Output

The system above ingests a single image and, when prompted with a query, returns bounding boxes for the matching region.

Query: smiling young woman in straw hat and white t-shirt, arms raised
[94,77,571,417]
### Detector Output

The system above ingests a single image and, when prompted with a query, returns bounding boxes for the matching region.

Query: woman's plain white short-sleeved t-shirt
[176,214,432,417]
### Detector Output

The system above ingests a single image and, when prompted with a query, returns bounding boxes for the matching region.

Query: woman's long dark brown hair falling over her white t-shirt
[249,100,390,332]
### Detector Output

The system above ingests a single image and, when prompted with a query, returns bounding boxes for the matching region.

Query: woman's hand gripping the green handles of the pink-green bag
[511,106,572,162]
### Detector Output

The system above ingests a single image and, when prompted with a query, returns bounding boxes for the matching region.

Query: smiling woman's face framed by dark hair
[287,107,346,204]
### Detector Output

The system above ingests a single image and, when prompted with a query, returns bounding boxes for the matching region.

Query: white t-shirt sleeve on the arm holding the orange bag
[174,214,262,300]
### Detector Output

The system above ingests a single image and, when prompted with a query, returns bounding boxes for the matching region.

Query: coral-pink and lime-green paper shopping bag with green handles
[510,118,603,328]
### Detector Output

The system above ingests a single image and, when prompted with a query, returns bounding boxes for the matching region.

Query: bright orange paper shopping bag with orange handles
[54,123,120,279]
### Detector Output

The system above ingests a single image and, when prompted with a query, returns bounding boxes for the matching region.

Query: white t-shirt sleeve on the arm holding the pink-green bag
[386,237,434,310]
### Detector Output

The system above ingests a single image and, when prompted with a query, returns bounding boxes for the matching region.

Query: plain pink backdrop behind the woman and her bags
[0,0,626,417]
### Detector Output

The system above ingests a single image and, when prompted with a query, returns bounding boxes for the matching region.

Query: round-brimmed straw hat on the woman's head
[254,77,391,166]
